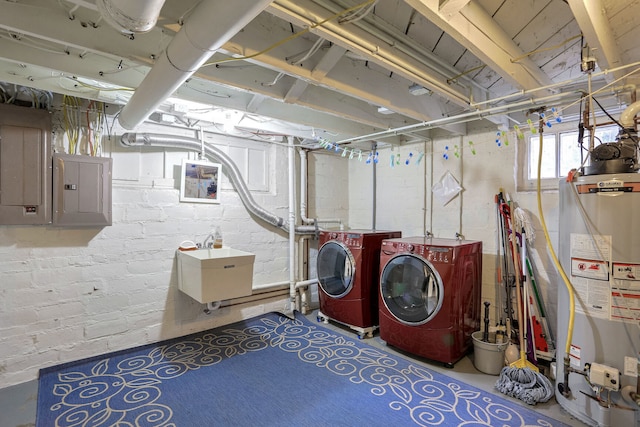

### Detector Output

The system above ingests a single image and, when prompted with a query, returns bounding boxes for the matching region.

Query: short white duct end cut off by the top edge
[96,0,165,34]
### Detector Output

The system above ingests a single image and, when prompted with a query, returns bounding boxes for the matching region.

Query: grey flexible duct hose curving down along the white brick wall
[120,133,318,234]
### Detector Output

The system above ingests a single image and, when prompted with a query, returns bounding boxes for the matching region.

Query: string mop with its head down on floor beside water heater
[496,230,554,405]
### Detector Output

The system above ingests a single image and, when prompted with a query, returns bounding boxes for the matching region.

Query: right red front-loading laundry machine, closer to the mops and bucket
[379,237,482,368]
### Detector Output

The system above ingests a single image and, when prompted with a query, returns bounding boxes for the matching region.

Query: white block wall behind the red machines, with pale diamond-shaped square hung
[349,125,560,346]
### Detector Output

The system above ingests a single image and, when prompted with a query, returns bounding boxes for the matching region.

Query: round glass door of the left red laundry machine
[317,240,356,298]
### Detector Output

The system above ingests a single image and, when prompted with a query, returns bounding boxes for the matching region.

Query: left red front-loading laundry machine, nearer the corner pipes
[317,230,402,338]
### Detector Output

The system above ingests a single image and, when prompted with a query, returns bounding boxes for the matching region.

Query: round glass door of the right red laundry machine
[380,254,444,325]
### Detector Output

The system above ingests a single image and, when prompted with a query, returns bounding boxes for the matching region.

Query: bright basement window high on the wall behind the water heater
[518,125,618,191]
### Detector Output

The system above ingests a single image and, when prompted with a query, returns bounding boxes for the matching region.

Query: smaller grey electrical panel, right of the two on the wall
[53,154,113,226]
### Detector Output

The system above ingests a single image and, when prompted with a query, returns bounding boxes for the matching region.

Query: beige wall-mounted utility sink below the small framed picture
[176,247,256,304]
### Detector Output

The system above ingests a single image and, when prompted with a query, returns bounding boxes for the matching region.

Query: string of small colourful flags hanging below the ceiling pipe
[315,107,562,167]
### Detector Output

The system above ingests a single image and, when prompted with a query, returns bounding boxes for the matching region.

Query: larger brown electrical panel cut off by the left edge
[0,104,52,225]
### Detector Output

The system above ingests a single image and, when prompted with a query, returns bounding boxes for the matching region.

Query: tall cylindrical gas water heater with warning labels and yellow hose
[556,103,640,427]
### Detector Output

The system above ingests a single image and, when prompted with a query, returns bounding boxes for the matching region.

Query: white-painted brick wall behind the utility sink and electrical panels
[0,118,346,387]
